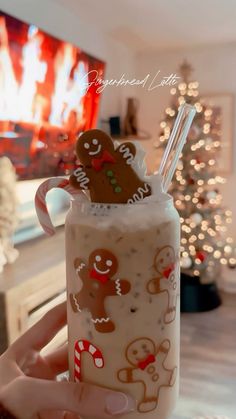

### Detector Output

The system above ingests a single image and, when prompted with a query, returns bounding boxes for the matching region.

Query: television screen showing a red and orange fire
[0,12,105,179]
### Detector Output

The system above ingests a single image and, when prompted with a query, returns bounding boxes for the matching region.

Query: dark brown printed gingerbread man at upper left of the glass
[70,249,130,333]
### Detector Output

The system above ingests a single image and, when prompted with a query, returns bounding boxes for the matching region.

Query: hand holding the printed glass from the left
[0,303,135,419]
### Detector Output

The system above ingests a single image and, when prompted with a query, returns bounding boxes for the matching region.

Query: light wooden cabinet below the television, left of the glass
[0,228,67,353]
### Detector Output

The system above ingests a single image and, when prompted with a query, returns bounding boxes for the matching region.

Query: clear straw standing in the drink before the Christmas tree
[159,104,196,192]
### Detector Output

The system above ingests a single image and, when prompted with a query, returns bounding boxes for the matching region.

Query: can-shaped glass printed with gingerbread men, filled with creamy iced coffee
[66,194,180,419]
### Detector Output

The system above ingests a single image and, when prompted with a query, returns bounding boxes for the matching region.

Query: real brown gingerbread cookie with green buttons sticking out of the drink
[70,129,151,204]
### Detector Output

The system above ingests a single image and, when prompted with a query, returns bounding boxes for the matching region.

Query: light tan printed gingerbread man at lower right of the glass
[118,338,177,413]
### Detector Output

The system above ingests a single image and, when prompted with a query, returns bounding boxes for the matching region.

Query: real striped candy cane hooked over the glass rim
[35,177,85,236]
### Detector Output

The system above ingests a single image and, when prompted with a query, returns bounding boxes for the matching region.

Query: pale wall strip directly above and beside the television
[0,0,134,124]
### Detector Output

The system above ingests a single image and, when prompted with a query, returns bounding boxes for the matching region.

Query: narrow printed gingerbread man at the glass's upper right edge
[147,246,178,323]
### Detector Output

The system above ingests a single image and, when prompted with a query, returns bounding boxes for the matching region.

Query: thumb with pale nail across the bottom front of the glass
[1,377,135,419]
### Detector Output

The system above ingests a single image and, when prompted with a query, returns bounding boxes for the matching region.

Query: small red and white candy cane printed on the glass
[74,339,104,382]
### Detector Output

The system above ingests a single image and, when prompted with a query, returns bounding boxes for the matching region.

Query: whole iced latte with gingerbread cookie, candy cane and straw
[35,108,196,419]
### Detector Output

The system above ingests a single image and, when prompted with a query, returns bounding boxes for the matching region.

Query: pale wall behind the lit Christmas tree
[137,44,236,238]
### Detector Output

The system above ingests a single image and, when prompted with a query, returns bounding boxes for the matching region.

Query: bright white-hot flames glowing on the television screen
[0,17,94,126]
